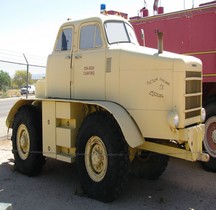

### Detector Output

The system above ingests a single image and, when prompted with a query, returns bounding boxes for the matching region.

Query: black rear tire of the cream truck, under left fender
[12,105,45,176]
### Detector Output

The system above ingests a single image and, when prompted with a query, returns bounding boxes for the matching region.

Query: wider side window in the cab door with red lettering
[80,25,102,50]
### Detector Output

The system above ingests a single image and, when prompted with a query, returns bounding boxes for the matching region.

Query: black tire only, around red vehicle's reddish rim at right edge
[201,103,216,172]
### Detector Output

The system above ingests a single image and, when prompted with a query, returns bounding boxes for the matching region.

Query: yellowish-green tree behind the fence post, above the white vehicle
[13,70,32,88]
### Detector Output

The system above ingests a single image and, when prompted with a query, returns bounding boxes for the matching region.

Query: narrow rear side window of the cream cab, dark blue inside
[56,28,73,51]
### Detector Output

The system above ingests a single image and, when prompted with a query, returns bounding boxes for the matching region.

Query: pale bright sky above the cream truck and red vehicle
[0,0,211,75]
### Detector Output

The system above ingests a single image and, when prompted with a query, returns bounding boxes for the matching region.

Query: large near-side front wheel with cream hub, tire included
[76,111,129,202]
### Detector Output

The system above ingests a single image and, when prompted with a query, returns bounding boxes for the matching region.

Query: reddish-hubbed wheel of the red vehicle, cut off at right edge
[202,104,216,172]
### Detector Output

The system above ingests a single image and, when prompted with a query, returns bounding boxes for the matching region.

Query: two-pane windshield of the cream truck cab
[104,21,137,44]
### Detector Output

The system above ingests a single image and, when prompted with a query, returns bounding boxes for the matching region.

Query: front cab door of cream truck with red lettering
[73,22,106,99]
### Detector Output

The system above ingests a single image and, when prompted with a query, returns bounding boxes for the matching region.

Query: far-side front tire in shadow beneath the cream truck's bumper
[132,151,169,180]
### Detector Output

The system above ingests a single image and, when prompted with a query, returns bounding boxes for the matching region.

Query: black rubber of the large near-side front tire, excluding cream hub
[76,111,130,202]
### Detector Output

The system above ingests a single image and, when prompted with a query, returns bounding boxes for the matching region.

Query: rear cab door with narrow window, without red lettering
[46,27,73,98]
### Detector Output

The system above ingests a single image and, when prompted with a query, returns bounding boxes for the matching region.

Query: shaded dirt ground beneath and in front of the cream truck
[0,138,216,210]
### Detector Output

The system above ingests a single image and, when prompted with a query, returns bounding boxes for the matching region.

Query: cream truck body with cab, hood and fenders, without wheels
[7,15,208,200]
